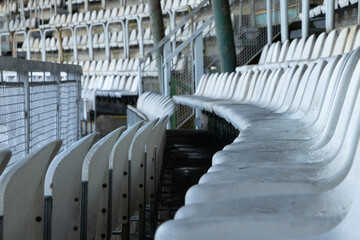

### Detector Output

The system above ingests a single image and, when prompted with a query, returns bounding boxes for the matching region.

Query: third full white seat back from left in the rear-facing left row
[80,127,125,239]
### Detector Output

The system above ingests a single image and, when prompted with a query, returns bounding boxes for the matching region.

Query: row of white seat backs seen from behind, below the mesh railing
[0,116,168,240]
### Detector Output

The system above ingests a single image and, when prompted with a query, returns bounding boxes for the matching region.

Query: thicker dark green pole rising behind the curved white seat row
[212,0,236,72]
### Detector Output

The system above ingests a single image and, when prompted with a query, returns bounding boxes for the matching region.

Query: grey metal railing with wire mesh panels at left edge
[0,57,82,161]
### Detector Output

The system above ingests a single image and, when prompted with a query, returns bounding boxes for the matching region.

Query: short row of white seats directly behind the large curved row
[237,25,360,71]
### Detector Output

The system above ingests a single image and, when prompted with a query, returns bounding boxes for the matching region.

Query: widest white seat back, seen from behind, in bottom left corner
[0,141,61,240]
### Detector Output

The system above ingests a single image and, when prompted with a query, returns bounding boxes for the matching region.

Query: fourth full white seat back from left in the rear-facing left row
[109,122,143,230]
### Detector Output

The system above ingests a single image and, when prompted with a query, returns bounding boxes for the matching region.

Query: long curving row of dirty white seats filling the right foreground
[155,41,360,240]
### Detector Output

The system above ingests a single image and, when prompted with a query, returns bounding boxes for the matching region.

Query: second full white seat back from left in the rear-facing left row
[44,133,99,240]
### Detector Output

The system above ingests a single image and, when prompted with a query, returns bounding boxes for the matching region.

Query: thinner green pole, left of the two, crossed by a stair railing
[149,0,165,90]
